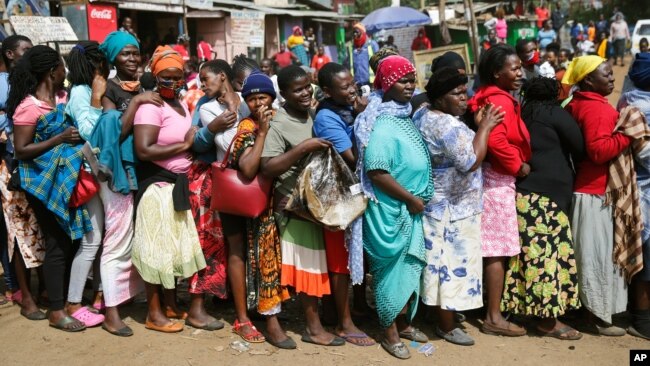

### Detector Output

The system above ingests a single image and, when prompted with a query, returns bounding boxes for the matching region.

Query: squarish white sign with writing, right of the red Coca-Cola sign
[230,11,264,55]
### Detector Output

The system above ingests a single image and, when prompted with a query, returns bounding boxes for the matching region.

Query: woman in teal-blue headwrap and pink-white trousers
[94,32,163,336]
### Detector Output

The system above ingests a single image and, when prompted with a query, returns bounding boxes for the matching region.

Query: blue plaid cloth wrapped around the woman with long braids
[19,104,92,240]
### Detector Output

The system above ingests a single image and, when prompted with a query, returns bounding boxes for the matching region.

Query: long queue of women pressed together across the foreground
[0,26,650,359]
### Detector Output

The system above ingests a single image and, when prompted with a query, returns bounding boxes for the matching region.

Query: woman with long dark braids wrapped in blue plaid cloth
[7,45,92,332]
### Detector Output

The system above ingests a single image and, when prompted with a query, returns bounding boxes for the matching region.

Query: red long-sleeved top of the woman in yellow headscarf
[566,92,631,194]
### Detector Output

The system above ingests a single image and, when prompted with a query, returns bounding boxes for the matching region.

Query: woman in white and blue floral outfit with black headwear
[413,67,504,346]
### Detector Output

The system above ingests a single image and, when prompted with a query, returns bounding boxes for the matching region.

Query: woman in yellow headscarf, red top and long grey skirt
[562,56,631,336]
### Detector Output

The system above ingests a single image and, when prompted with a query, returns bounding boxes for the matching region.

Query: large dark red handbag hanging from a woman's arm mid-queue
[210,131,273,218]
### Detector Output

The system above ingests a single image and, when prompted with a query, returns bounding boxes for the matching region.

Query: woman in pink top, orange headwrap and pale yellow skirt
[133,46,206,333]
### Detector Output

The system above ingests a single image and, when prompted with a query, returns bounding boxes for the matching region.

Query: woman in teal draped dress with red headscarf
[363,56,433,359]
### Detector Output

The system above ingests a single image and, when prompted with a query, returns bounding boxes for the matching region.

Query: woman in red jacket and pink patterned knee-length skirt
[469,44,531,336]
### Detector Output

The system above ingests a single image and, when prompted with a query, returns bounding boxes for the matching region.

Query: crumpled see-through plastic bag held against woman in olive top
[285,148,368,231]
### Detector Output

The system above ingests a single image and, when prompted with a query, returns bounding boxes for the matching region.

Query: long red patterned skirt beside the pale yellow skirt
[188,161,228,299]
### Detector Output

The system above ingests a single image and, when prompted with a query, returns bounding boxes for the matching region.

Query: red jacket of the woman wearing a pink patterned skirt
[468,85,531,176]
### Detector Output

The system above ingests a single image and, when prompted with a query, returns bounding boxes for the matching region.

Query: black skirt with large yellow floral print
[501,193,580,318]
